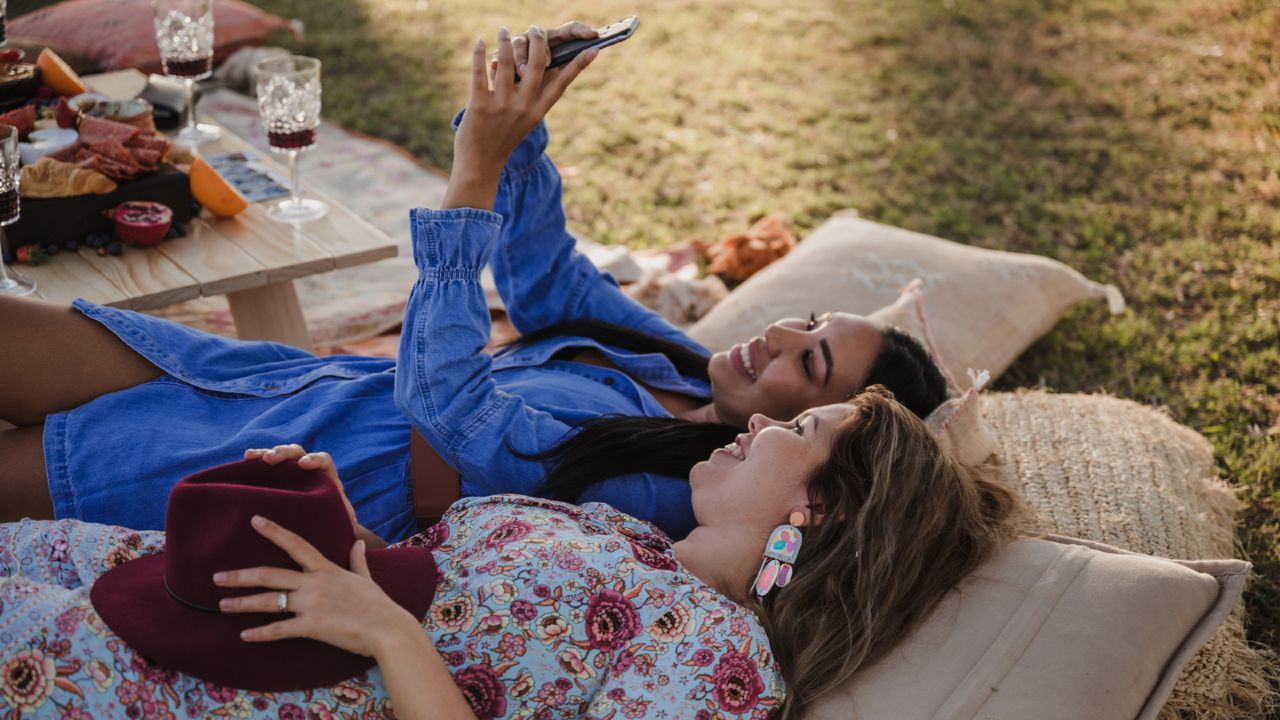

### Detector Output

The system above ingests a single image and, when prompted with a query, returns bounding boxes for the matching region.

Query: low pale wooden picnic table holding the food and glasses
[17,119,397,350]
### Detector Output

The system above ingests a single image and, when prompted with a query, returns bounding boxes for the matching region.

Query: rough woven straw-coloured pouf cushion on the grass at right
[983,391,1277,720]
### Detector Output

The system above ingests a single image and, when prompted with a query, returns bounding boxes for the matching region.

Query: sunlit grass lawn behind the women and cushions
[10,0,1280,666]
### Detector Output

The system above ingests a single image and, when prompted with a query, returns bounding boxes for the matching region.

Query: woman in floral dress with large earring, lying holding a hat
[0,388,1019,720]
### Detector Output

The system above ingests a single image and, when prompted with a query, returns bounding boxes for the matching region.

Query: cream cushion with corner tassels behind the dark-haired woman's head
[689,211,1124,386]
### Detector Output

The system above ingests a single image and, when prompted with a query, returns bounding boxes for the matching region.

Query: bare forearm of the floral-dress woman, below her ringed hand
[378,625,475,720]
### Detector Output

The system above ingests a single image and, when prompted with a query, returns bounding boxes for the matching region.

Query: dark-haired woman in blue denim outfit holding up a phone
[0,23,946,539]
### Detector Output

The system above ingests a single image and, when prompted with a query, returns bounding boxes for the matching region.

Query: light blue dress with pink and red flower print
[0,496,783,720]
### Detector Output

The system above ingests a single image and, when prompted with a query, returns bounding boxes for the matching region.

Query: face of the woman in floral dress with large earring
[689,404,855,533]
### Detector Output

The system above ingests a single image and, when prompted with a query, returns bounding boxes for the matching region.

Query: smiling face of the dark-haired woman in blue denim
[708,313,884,428]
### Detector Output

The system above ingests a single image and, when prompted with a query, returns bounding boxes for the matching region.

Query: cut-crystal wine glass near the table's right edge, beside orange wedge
[253,55,329,223]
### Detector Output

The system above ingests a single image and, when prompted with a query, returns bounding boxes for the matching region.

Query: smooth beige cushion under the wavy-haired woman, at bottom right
[810,538,1249,720]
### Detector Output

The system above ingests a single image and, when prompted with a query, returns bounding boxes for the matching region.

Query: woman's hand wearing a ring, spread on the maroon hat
[214,515,422,657]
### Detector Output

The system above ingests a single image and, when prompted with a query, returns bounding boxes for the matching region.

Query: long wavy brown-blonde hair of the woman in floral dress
[748,386,1024,720]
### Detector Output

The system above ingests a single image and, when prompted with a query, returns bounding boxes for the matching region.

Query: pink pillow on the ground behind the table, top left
[9,0,291,73]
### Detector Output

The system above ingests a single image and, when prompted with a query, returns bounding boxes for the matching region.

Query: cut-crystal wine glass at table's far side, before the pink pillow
[151,0,223,145]
